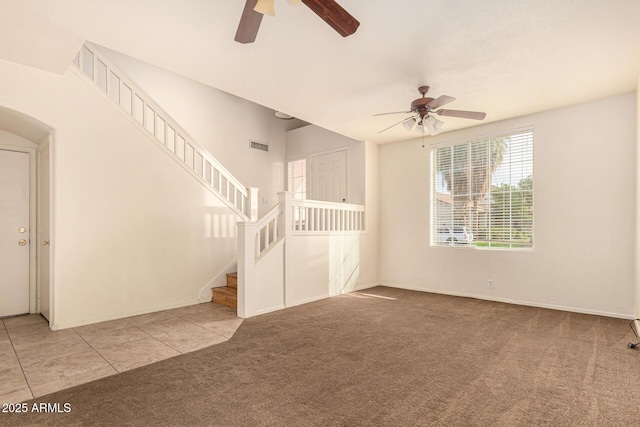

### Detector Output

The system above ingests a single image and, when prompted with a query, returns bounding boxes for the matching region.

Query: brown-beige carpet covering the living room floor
[0,287,640,426]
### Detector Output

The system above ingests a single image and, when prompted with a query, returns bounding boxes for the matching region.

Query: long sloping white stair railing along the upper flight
[73,42,257,221]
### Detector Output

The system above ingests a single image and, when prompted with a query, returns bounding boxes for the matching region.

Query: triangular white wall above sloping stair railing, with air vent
[100,48,290,216]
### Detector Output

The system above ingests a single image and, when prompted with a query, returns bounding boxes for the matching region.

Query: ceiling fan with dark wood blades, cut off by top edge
[235,0,360,43]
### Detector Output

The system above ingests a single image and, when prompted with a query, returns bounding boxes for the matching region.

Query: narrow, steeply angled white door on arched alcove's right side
[38,144,51,320]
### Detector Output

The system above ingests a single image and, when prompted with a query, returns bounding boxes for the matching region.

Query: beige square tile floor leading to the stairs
[0,303,242,403]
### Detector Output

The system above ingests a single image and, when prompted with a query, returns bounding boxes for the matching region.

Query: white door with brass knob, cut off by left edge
[0,150,29,316]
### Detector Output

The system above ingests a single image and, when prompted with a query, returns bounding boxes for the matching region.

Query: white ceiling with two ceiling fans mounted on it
[0,0,640,143]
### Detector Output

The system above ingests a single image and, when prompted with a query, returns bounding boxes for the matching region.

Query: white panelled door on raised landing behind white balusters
[311,150,347,202]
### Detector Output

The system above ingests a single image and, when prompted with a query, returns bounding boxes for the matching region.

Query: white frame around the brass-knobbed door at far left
[0,140,38,313]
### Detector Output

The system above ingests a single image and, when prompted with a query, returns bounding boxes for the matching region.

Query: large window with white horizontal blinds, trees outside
[431,129,533,249]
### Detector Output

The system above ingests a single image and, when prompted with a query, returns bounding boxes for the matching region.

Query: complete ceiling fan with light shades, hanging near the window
[374,86,487,135]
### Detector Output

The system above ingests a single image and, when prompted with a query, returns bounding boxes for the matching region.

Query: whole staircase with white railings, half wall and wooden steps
[70,42,365,318]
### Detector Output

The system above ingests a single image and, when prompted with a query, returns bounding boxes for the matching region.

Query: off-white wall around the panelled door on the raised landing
[286,125,365,205]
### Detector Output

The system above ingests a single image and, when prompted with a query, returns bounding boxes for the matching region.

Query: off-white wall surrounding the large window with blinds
[380,94,637,317]
